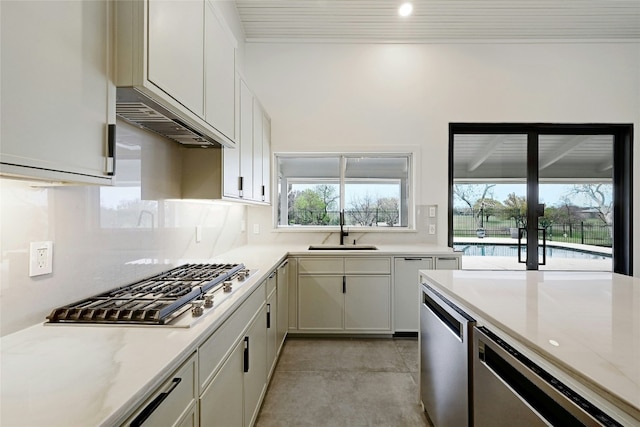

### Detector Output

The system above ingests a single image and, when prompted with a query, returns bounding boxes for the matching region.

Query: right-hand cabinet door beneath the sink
[344,276,391,331]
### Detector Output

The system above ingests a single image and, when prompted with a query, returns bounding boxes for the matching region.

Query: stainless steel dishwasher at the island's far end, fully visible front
[420,282,475,427]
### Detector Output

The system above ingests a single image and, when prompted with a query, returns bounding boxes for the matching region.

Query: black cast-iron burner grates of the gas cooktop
[47,264,244,325]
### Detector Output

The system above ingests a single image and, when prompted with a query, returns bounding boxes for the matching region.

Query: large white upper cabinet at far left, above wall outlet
[0,0,115,185]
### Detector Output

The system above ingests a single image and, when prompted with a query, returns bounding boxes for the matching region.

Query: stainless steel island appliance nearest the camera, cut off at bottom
[473,327,622,427]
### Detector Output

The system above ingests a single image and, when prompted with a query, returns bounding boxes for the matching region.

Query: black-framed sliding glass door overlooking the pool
[449,124,632,274]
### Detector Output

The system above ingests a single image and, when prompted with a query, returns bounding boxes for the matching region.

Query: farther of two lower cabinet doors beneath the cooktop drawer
[244,306,267,426]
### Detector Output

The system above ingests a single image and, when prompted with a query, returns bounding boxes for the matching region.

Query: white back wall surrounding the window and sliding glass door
[244,43,640,270]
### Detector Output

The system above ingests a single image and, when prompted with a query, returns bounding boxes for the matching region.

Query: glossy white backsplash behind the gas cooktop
[0,121,247,335]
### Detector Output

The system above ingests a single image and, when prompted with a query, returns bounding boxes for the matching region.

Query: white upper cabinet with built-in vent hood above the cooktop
[114,0,237,147]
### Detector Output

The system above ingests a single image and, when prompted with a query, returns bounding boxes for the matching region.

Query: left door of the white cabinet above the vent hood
[147,0,204,117]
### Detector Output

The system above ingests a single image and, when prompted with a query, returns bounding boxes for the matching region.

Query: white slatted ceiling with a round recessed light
[236,0,640,43]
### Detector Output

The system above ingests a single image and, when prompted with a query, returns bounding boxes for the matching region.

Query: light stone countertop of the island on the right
[421,270,640,425]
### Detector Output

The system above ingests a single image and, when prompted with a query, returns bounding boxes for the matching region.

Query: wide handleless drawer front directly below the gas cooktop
[198,282,265,391]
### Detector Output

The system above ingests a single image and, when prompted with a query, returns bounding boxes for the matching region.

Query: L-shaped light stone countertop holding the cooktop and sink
[0,245,451,427]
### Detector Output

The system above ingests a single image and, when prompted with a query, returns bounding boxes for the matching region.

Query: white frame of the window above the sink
[272,151,417,233]
